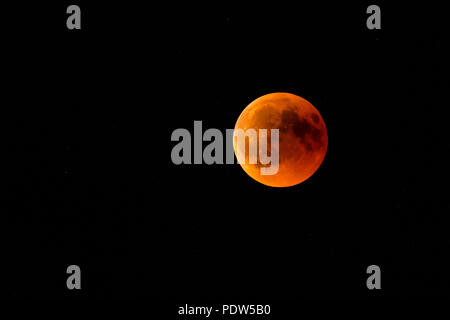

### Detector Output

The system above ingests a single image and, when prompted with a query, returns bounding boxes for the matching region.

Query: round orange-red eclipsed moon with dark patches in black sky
[233,92,328,187]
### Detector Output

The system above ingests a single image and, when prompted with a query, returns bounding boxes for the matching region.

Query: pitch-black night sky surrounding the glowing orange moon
[0,1,449,303]
